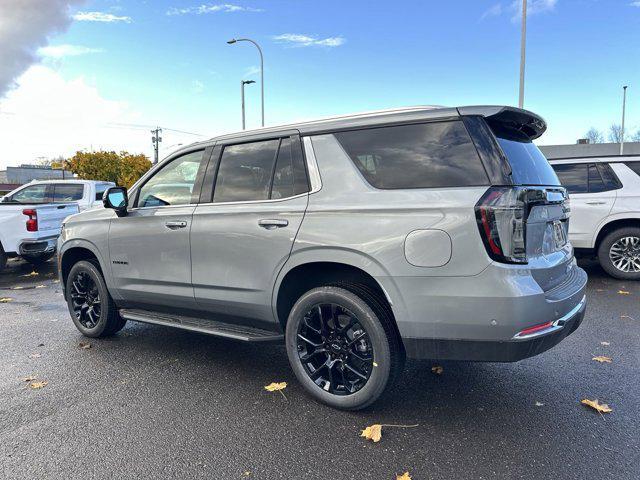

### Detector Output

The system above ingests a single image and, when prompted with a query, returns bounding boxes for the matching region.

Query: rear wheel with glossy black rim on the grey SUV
[285,283,404,410]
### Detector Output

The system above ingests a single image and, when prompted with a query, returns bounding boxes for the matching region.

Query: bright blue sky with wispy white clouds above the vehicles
[0,0,640,165]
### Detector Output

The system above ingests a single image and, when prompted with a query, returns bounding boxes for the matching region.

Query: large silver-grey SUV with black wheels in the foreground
[58,106,587,409]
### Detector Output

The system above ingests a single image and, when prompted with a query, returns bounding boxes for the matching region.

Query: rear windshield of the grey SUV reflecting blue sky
[497,133,560,185]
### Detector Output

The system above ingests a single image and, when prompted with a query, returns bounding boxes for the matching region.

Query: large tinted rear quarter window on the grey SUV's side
[335,120,489,189]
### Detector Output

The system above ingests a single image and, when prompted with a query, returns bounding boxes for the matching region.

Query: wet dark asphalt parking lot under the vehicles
[0,261,640,479]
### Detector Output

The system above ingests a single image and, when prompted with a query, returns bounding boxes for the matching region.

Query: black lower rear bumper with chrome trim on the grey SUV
[403,297,587,362]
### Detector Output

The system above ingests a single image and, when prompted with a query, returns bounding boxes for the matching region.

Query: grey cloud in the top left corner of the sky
[0,0,82,98]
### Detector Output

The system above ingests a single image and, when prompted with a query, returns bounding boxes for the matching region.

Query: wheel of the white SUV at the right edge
[598,227,640,280]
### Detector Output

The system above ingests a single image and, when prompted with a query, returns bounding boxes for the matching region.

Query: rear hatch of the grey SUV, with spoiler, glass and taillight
[464,108,573,292]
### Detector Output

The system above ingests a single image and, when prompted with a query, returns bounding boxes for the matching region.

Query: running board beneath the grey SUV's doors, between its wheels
[120,309,284,342]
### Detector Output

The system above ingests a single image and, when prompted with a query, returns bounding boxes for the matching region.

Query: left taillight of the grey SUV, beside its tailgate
[475,187,527,263]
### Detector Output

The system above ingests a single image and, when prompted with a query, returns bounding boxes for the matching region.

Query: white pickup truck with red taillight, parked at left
[0,180,114,271]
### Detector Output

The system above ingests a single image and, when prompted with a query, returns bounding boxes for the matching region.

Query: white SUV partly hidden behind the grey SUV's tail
[551,156,640,280]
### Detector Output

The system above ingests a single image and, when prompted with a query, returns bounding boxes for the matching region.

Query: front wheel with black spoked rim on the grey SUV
[66,260,127,338]
